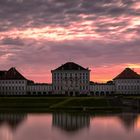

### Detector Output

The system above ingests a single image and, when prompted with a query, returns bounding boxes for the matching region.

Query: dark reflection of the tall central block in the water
[52,113,90,132]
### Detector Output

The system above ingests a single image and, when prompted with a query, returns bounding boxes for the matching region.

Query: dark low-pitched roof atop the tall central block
[52,62,88,70]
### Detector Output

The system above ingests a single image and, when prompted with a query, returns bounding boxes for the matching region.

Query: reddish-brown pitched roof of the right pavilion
[114,68,140,80]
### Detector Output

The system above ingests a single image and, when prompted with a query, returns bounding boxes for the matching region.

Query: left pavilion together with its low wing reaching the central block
[0,68,52,96]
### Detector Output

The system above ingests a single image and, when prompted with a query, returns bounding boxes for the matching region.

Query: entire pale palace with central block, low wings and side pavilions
[0,62,140,96]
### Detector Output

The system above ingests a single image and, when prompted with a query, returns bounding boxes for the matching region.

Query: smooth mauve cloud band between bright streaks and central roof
[0,37,140,67]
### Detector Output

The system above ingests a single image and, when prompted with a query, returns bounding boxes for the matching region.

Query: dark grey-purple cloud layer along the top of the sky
[0,0,140,31]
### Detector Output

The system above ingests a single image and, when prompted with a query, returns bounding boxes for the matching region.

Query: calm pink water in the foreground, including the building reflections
[0,113,140,140]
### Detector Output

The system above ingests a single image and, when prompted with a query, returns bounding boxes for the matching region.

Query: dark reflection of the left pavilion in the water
[0,113,27,130]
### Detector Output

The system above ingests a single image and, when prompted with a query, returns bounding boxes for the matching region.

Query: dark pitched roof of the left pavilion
[0,67,26,80]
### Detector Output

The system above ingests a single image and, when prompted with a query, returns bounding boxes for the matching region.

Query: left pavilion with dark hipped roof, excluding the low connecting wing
[0,68,27,95]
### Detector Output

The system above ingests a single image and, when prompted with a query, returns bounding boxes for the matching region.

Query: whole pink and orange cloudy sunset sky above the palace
[0,0,140,82]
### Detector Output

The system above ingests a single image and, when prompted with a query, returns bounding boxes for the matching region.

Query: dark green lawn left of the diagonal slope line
[0,97,66,108]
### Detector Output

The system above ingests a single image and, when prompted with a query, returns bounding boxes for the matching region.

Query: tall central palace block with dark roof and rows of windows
[51,62,90,96]
